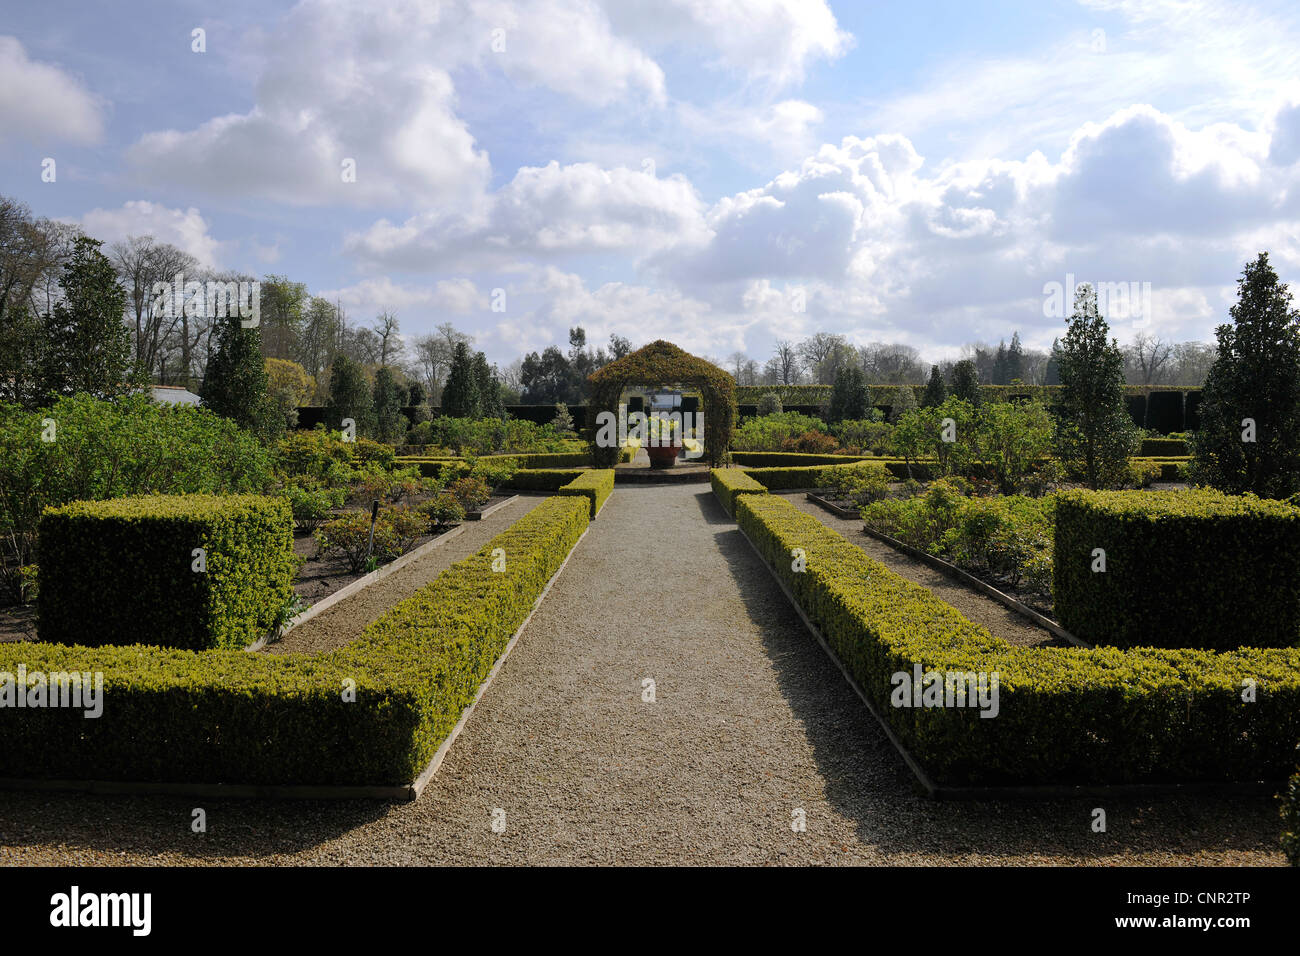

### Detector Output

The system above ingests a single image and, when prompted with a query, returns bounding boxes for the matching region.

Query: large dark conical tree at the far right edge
[1192,252,1300,498]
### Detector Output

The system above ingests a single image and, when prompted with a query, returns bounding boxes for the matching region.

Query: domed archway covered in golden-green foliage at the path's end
[586,339,736,468]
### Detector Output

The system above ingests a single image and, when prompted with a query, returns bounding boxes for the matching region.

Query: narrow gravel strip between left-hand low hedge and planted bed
[263,496,546,654]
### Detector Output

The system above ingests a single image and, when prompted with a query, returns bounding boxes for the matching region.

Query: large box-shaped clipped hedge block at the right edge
[1053,489,1300,650]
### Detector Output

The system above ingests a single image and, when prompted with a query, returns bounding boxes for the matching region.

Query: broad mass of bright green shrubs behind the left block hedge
[0,395,270,600]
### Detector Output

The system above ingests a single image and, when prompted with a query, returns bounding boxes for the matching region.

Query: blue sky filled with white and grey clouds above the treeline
[0,0,1300,364]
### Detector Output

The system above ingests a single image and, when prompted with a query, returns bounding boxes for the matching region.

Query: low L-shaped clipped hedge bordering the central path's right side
[736,494,1300,786]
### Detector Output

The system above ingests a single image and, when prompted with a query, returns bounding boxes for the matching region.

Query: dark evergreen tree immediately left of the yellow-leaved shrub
[202,315,276,438]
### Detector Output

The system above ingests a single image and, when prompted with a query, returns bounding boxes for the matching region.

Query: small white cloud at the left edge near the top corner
[0,36,105,146]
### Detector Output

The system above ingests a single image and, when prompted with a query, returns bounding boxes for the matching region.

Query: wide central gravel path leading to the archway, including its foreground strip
[0,485,1282,865]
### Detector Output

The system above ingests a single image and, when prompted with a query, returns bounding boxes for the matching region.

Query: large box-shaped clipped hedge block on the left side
[38,494,298,650]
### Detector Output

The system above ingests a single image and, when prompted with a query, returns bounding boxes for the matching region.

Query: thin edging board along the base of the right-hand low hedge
[736,524,1286,801]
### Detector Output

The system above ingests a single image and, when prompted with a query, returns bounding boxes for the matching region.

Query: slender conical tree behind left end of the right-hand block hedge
[1056,284,1138,488]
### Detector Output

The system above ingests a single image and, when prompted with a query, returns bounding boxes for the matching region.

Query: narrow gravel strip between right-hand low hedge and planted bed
[781,492,1070,648]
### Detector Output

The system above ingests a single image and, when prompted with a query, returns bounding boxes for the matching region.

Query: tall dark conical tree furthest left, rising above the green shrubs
[40,235,139,398]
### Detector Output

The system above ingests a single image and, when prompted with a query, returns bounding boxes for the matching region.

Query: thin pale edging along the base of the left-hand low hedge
[0,524,592,803]
